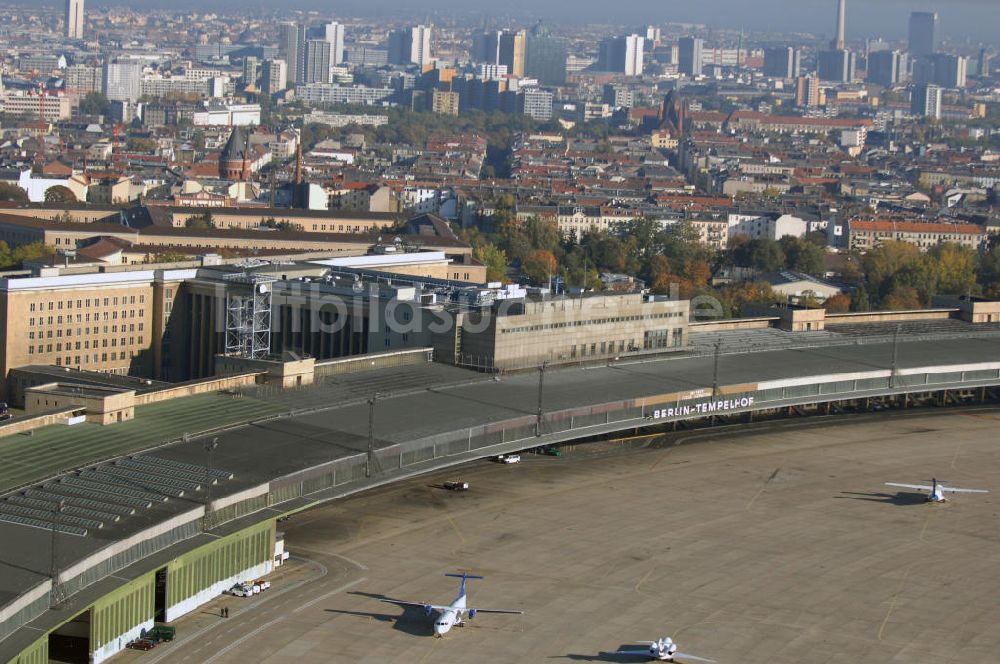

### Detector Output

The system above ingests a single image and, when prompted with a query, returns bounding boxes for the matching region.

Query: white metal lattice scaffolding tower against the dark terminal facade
[225,272,277,359]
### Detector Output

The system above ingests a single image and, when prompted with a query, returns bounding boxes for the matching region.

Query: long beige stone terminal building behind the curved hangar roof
[0,246,688,405]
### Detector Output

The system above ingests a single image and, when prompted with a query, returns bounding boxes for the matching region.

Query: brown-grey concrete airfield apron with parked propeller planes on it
[137,409,1000,664]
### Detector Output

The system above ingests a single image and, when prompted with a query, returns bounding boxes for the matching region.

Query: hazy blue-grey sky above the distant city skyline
[92,0,1000,44]
